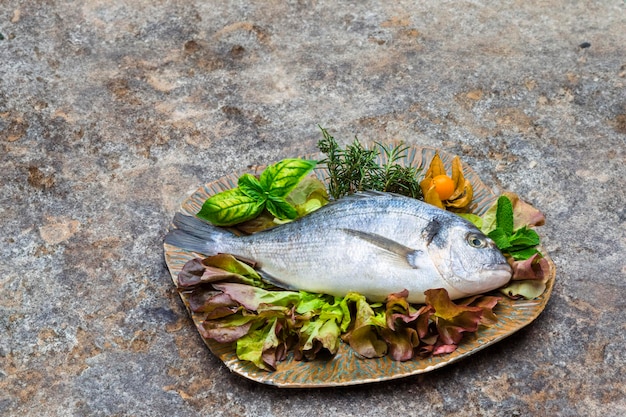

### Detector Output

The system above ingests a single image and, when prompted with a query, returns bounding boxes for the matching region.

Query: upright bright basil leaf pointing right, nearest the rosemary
[259,158,317,198]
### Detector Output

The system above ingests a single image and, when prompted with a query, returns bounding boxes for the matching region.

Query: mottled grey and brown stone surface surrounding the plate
[0,0,626,417]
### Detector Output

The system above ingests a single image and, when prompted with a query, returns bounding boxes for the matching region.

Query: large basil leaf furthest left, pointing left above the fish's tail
[198,188,265,226]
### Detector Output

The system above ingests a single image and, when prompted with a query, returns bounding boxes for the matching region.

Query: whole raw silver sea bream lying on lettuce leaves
[165,192,511,303]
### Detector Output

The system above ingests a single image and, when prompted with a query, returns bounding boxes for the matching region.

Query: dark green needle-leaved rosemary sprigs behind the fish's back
[317,127,423,200]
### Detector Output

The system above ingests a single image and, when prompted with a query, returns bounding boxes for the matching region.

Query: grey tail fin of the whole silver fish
[165,213,232,255]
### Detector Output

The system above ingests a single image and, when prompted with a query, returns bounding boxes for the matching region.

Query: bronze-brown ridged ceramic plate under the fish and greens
[165,147,556,388]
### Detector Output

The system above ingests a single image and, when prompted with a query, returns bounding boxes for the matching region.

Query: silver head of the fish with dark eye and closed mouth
[428,222,512,298]
